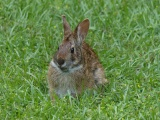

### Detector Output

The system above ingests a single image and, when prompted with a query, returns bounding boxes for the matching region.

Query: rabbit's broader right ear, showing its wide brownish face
[74,19,89,44]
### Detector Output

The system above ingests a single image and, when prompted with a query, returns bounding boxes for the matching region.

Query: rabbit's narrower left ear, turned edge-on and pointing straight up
[62,15,71,37]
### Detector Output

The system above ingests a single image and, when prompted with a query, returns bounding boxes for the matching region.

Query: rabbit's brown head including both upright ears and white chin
[54,16,89,72]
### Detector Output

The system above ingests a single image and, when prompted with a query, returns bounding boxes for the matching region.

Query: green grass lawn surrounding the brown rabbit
[0,0,160,120]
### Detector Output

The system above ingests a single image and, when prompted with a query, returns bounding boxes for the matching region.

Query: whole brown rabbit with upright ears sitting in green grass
[48,16,108,101]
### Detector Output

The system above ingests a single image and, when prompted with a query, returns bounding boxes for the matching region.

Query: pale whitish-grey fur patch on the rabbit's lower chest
[55,75,77,97]
